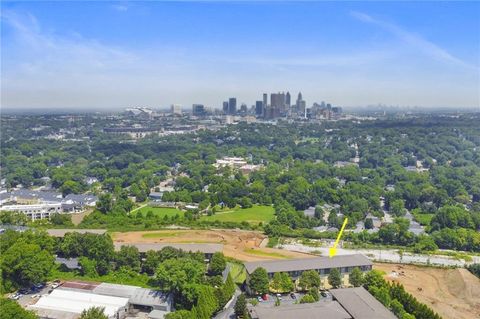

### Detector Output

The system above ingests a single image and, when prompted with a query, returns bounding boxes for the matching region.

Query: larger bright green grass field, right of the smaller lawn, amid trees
[200,205,275,224]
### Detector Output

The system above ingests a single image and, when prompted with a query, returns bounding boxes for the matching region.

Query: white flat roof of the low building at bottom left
[30,289,128,317]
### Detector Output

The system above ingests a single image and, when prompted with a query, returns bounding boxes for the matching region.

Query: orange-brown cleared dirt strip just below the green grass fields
[112,229,313,261]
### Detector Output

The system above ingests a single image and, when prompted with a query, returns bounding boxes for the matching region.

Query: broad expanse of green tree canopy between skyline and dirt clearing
[1,115,480,251]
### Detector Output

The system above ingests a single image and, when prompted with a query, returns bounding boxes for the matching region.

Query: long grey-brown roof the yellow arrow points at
[245,254,372,274]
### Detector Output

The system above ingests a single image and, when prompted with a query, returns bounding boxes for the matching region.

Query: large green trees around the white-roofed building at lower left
[0,230,235,319]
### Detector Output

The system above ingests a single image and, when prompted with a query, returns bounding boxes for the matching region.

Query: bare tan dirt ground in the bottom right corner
[374,263,480,319]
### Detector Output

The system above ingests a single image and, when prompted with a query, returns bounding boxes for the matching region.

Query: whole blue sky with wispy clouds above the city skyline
[1,1,480,109]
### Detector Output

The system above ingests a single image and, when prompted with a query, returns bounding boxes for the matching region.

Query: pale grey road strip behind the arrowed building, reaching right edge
[281,243,480,267]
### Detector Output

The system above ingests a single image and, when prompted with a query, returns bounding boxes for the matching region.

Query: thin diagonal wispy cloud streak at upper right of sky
[350,11,475,68]
